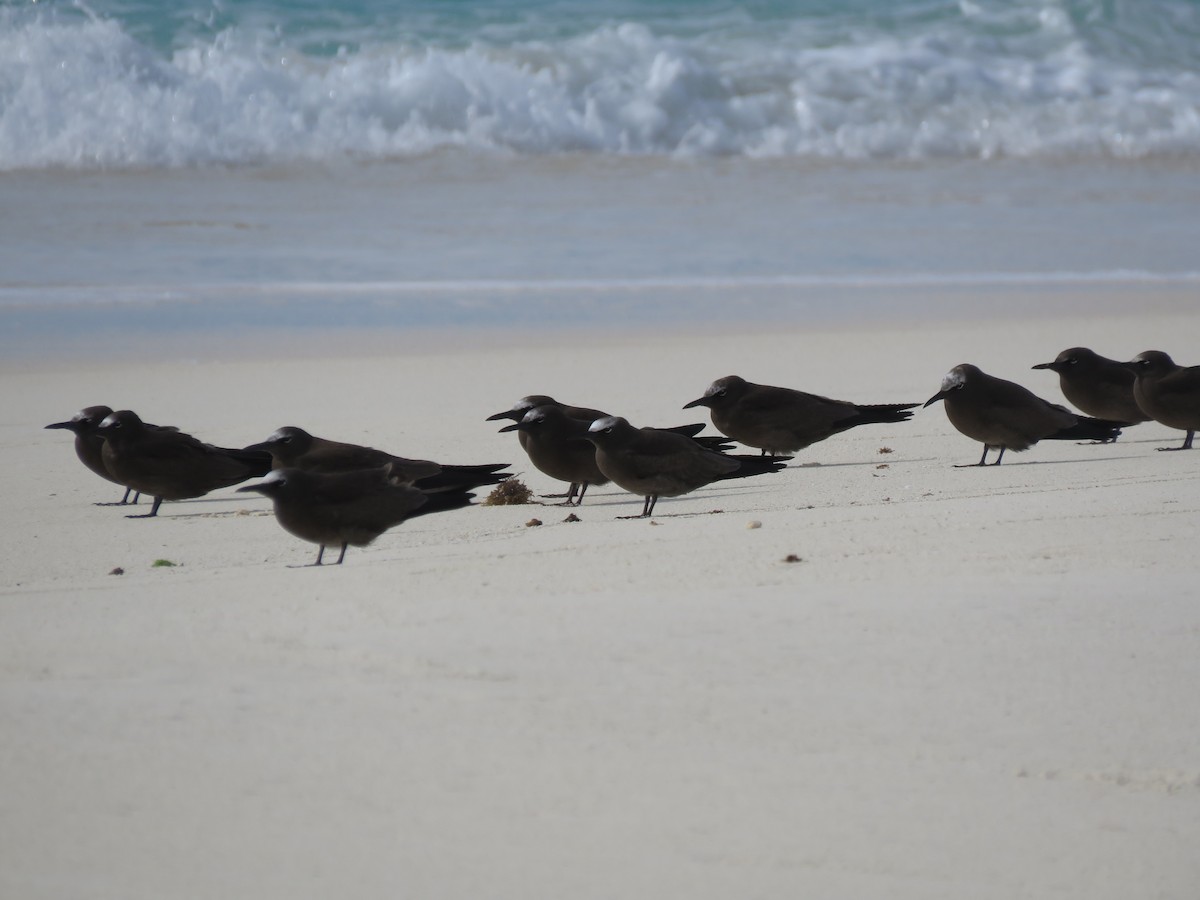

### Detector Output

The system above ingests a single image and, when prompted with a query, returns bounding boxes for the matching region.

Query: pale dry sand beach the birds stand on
[0,307,1200,900]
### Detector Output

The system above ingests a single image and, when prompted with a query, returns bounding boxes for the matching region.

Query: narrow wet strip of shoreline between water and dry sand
[0,281,1198,372]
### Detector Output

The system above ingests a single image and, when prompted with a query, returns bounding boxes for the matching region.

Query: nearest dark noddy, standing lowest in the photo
[238,463,474,565]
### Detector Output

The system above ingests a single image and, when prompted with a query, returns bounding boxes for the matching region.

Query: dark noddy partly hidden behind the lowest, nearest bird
[247,425,510,491]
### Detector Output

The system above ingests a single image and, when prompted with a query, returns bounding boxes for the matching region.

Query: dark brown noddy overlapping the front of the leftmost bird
[98,409,271,518]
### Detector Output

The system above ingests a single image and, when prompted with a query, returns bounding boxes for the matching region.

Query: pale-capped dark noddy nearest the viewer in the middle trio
[588,416,791,518]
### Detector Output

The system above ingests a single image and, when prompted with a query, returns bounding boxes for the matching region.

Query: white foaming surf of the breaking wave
[0,6,1200,170]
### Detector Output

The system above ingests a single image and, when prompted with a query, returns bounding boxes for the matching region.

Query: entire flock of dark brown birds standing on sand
[46,347,1200,565]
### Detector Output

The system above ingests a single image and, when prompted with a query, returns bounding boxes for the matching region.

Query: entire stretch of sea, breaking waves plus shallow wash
[0,0,1200,348]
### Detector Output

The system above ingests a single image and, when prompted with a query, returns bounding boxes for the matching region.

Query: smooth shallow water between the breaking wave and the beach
[0,154,1200,353]
